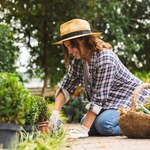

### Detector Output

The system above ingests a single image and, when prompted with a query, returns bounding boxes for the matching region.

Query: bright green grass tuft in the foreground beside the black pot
[16,131,66,150]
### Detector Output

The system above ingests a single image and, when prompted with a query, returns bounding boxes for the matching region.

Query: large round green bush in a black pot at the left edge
[0,73,30,148]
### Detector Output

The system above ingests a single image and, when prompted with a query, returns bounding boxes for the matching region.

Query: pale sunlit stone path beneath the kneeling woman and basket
[65,124,150,150]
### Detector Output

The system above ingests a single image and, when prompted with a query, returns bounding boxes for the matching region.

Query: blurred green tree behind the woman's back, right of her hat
[94,0,150,71]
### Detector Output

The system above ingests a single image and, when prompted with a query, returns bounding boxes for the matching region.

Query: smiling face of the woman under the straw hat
[63,41,81,59]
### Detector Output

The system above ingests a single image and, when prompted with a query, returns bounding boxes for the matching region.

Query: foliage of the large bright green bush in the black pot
[0,73,30,125]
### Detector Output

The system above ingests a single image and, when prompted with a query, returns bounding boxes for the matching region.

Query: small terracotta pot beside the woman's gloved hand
[38,121,49,134]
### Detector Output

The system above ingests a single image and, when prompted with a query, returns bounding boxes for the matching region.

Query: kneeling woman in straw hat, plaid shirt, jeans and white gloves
[50,19,148,138]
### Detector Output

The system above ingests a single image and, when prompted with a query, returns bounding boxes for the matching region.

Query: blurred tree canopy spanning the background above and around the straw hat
[0,0,150,92]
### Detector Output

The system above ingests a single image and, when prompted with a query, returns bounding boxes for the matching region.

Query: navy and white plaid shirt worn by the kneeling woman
[61,50,148,109]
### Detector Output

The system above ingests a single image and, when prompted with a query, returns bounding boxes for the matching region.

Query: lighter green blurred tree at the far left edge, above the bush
[0,25,19,73]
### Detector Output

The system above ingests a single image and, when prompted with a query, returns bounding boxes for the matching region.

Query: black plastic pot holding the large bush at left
[0,123,21,149]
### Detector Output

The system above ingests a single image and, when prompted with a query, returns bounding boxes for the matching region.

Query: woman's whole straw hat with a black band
[53,19,101,44]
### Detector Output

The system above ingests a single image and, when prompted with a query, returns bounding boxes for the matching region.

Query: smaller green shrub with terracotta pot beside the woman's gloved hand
[23,95,50,134]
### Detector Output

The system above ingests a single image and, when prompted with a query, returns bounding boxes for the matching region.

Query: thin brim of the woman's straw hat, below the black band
[53,32,102,45]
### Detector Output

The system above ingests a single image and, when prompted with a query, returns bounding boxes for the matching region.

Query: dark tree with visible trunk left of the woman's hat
[1,0,94,96]
